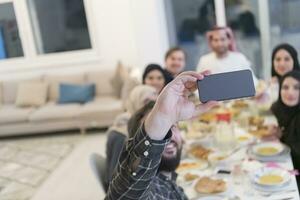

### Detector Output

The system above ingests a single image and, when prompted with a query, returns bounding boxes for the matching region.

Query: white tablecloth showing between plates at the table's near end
[182,127,300,200]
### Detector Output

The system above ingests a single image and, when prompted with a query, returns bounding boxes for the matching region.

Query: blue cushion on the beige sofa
[58,83,95,104]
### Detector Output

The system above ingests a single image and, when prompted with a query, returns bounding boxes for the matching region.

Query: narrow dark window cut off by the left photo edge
[0,3,23,59]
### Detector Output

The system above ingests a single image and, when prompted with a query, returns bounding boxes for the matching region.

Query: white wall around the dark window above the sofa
[0,0,169,79]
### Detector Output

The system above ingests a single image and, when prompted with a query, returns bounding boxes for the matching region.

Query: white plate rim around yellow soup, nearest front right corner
[251,167,291,188]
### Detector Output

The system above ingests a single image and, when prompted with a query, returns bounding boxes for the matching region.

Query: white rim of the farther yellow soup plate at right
[252,142,284,157]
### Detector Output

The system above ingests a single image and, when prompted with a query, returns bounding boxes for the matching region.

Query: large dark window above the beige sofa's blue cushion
[28,0,91,54]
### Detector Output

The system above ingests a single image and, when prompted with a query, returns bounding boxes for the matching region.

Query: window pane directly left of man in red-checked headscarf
[172,0,216,70]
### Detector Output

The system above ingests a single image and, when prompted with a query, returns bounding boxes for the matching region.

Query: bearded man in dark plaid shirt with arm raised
[105,72,217,200]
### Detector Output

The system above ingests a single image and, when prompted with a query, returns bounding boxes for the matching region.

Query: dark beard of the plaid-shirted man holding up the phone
[158,148,182,172]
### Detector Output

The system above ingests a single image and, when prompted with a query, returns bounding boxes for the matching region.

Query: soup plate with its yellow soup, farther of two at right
[252,142,284,157]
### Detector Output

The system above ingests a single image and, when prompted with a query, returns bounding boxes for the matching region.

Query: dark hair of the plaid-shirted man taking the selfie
[127,101,155,138]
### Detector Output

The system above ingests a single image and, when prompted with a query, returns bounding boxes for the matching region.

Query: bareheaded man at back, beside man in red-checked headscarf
[164,47,186,84]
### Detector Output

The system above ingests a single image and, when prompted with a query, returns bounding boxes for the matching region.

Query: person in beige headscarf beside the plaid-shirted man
[104,85,158,190]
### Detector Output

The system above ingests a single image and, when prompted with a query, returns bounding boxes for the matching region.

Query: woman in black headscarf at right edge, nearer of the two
[271,71,300,188]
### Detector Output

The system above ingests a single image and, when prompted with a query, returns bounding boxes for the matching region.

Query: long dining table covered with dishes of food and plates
[176,99,299,200]
